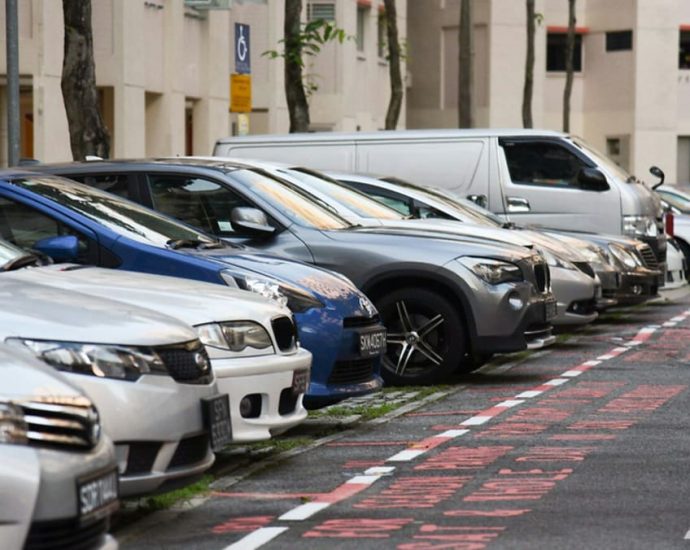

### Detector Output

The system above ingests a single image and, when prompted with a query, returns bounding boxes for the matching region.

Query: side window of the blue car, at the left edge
[0,197,90,263]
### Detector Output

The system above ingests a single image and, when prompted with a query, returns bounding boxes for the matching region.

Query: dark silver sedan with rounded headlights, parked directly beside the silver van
[330,173,663,309]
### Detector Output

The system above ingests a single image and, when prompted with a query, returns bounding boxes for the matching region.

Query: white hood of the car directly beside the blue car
[5,264,290,325]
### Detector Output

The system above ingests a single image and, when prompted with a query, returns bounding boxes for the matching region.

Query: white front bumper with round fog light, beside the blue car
[211,349,311,443]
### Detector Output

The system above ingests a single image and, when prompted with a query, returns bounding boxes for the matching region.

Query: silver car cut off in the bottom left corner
[0,345,118,550]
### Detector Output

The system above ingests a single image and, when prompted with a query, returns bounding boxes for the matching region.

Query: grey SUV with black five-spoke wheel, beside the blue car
[32,158,554,384]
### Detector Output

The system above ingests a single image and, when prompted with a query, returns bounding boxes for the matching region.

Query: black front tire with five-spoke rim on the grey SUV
[375,288,467,386]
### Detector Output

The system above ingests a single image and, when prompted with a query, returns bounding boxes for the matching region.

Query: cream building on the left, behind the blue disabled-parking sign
[0,0,406,165]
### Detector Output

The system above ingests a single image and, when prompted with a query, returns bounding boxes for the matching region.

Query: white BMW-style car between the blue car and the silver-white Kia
[0,240,311,443]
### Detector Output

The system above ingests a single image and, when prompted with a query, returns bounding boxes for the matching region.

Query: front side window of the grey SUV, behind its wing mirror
[146,174,253,234]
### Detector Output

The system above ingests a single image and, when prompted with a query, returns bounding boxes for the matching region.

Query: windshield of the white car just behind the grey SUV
[280,168,405,220]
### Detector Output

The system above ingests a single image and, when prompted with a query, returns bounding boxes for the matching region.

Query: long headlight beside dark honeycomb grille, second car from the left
[6,338,168,381]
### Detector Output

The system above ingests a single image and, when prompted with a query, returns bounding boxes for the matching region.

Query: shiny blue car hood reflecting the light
[190,249,372,317]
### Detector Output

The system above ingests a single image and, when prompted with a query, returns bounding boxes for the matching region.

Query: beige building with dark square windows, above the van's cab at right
[407,0,690,182]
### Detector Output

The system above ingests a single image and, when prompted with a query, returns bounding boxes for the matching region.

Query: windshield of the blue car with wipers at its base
[12,176,223,248]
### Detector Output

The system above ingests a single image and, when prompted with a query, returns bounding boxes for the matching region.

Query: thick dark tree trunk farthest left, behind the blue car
[61,0,110,160]
